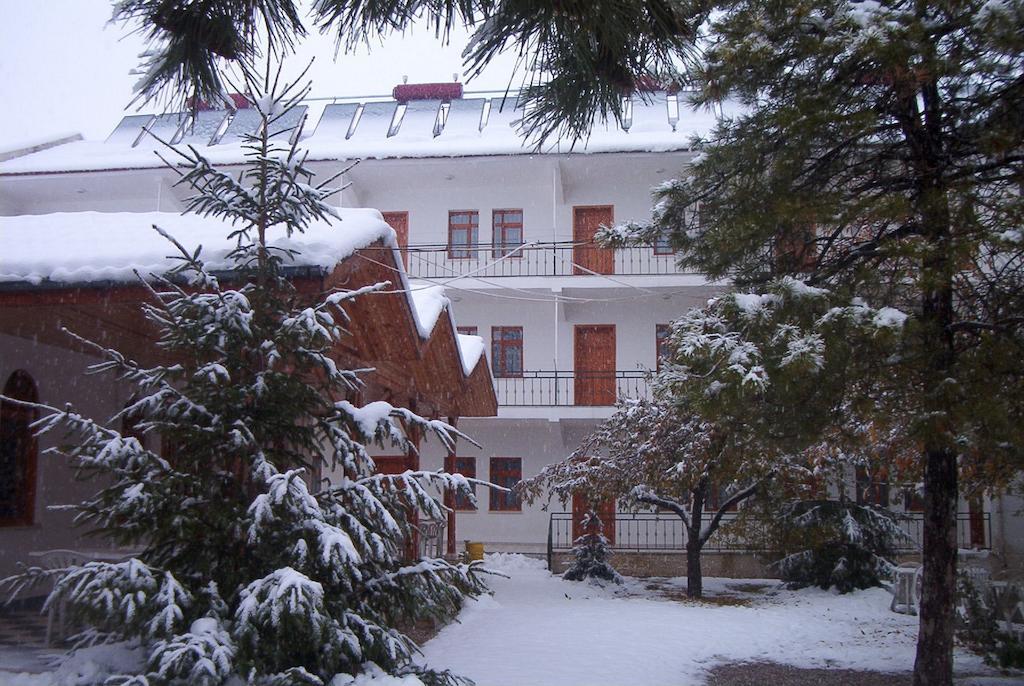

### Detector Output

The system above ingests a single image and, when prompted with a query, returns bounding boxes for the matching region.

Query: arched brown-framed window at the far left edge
[0,370,39,526]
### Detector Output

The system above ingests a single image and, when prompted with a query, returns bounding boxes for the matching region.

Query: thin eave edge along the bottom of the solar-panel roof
[0,143,693,177]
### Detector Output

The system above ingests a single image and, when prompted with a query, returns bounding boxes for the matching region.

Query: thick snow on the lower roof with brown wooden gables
[0,208,491,384]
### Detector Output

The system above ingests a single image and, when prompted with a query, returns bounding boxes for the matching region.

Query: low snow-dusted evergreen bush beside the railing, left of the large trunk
[774,500,905,593]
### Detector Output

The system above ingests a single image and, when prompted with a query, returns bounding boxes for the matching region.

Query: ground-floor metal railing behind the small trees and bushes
[548,512,992,553]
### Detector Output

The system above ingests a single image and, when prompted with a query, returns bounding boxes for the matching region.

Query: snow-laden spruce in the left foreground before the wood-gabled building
[1,75,484,686]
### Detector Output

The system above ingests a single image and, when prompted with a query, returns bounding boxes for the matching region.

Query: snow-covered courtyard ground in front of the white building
[0,554,1020,686]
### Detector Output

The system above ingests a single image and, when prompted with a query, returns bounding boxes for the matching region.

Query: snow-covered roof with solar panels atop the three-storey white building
[0,92,731,174]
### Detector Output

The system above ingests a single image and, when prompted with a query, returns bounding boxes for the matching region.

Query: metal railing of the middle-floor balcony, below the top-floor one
[494,370,649,408]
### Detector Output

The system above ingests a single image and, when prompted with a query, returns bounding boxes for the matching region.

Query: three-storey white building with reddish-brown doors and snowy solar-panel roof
[0,79,1021,573]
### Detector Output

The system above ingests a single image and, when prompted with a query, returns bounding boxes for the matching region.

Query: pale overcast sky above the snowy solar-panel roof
[0,0,518,152]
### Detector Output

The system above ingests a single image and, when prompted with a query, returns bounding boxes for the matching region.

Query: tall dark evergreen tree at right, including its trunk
[598,0,1024,686]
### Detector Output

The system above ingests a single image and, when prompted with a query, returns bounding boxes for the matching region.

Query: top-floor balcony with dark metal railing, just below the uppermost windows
[402,241,687,278]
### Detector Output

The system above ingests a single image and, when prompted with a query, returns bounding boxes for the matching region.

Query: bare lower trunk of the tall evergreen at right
[913,448,956,686]
